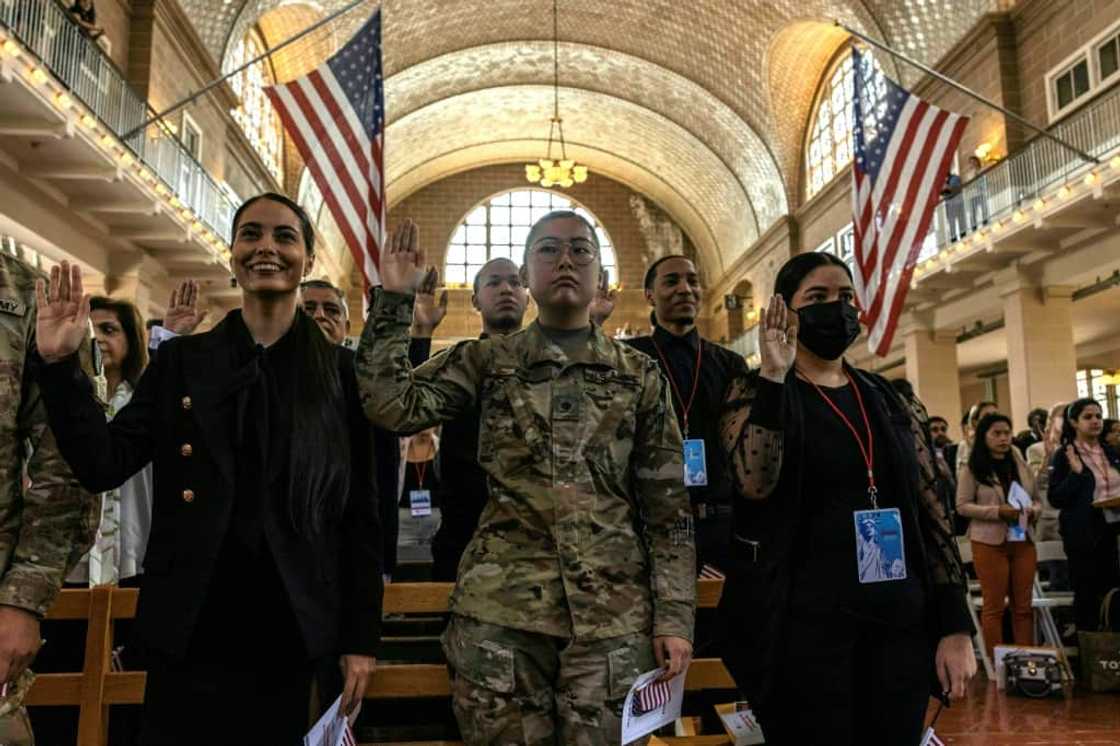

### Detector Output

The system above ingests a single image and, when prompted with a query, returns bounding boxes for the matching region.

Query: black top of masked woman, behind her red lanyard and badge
[791,379,924,627]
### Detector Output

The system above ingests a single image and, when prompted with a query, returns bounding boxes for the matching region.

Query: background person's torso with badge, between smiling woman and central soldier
[396,428,441,562]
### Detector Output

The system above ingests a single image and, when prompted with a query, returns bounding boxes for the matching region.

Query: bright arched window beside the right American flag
[805,45,886,199]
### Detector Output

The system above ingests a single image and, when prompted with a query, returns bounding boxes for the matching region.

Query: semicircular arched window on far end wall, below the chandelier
[444,189,618,286]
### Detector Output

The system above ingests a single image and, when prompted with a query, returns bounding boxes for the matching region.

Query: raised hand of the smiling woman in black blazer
[35,261,90,363]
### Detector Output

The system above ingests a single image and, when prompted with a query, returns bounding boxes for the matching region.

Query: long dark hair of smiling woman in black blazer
[233,192,351,528]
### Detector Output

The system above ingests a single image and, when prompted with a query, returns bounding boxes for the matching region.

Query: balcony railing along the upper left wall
[0,0,236,241]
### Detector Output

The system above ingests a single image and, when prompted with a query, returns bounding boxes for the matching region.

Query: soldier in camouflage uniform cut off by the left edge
[0,251,100,746]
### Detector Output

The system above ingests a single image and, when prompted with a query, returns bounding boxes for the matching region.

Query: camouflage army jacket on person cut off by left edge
[0,252,97,616]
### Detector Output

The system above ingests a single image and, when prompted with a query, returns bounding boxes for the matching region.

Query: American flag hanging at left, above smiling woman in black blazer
[264,9,385,288]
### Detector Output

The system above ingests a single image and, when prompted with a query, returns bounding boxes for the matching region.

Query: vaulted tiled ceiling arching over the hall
[179,0,1009,274]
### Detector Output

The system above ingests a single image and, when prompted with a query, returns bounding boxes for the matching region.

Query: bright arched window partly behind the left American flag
[227,29,283,181]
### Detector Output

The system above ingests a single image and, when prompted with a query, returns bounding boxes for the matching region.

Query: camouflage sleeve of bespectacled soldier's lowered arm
[633,361,697,641]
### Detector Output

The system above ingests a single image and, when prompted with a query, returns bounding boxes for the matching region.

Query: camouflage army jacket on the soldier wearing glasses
[357,291,696,641]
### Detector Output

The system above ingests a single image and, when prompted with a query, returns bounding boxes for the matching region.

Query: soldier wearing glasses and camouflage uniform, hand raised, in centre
[357,212,696,746]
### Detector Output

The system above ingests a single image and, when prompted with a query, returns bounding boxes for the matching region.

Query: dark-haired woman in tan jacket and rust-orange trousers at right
[956,413,1043,656]
